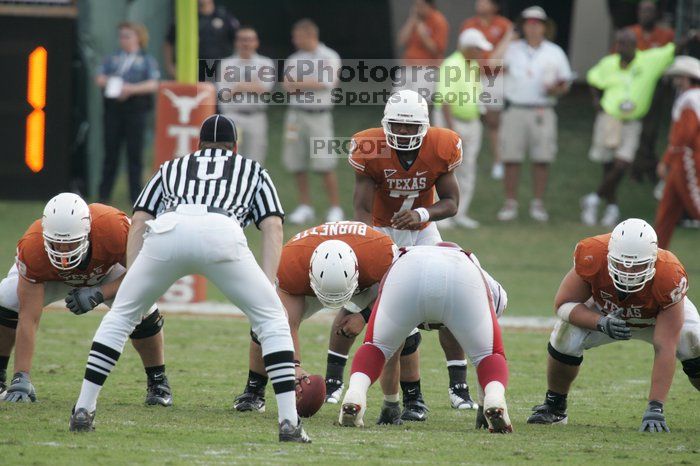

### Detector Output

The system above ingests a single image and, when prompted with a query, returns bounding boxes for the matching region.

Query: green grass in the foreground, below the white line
[0,312,700,465]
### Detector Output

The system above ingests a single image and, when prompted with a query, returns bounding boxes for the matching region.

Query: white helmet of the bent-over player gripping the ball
[309,239,360,309]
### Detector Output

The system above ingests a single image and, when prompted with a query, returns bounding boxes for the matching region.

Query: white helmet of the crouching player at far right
[608,218,659,293]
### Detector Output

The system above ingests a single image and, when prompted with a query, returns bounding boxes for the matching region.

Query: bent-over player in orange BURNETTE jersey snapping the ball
[234,222,421,424]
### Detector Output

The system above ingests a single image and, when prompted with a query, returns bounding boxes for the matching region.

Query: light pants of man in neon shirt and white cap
[433,108,483,217]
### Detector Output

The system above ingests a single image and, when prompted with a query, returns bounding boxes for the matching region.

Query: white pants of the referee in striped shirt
[94,206,294,355]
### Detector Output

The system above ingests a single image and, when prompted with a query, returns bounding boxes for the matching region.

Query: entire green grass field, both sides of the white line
[0,90,700,464]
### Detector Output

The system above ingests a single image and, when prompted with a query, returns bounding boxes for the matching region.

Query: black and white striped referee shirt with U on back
[134,149,284,227]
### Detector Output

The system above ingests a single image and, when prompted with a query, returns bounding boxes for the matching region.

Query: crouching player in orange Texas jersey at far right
[528,218,700,432]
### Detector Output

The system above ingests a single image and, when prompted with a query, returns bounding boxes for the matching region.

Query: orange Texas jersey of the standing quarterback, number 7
[348,127,462,229]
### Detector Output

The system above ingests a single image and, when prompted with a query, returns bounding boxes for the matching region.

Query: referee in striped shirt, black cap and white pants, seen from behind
[70,115,310,443]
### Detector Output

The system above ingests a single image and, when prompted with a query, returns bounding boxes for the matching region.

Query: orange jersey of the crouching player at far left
[16,204,130,287]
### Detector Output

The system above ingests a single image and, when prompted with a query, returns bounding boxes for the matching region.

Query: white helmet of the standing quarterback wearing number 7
[382,89,430,150]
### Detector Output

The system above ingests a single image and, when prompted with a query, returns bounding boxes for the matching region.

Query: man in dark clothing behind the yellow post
[163,0,239,81]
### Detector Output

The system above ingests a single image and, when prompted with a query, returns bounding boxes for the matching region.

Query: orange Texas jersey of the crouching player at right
[574,233,688,327]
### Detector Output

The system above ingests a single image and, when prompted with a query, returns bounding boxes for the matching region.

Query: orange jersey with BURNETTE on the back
[277,222,395,296]
